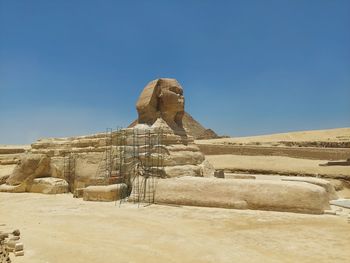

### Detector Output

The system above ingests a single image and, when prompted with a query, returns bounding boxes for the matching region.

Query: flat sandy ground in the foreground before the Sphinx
[0,193,350,263]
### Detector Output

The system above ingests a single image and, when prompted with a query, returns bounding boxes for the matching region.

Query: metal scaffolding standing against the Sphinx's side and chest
[96,128,164,205]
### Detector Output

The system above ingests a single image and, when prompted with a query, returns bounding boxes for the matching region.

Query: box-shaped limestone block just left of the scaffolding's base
[83,184,127,202]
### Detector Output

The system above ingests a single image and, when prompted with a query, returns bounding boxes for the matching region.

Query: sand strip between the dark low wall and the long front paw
[205,154,350,179]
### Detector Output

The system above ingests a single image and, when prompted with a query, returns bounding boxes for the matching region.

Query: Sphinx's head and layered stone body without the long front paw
[0,79,214,199]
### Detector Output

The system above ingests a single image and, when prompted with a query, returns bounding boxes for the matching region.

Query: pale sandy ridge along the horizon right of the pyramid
[196,128,350,144]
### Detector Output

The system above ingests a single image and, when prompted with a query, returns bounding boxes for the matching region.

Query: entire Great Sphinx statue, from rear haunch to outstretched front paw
[0,78,336,213]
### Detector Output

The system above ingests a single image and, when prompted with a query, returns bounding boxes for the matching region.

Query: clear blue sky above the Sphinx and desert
[0,0,350,144]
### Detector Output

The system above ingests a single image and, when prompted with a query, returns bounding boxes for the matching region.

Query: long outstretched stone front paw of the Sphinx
[155,177,330,214]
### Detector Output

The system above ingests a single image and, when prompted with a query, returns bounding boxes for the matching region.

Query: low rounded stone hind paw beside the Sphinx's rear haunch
[28,177,69,194]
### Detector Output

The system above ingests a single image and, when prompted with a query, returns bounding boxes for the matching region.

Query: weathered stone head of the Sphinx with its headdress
[136,79,185,128]
